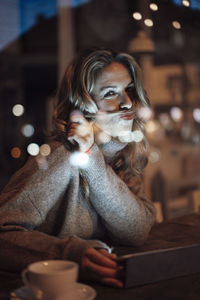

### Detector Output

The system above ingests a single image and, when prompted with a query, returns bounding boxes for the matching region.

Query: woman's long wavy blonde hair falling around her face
[53,48,149,191]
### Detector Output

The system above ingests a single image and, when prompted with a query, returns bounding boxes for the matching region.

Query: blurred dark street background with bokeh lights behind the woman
[0,0,200,222]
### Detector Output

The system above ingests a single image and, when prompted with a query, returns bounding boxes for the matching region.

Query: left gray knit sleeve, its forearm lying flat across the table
[0,142,106,272]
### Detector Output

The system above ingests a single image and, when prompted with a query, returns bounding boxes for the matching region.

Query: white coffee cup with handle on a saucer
[22,260,78,300]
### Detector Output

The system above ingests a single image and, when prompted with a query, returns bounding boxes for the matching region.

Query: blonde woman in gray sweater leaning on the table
[0,49,155,287]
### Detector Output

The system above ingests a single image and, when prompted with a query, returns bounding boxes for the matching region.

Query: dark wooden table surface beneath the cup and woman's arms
[0,214,200,300]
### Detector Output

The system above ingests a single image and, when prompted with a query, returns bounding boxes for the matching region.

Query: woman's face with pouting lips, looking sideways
[93,62,134,137]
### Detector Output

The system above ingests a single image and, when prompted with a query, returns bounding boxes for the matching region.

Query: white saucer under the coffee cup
[10,283,96,300]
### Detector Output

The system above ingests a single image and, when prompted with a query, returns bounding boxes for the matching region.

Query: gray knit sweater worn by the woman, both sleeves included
[0,141,155,271]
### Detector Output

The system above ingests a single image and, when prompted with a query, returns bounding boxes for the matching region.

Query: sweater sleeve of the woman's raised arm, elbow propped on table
[84,145,155,246]
